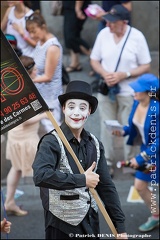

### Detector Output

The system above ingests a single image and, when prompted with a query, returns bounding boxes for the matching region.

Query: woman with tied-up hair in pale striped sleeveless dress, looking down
[26,10,63,132]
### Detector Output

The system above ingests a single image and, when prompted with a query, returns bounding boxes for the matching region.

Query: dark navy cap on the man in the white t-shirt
[103,4,130,22]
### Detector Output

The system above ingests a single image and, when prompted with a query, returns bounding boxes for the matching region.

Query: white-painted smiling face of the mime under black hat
[63,99,90,129]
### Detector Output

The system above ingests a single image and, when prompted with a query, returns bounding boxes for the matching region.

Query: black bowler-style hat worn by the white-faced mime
[58,80,98,114]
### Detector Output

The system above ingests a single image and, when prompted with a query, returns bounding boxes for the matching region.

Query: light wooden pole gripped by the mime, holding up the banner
[46,111,117,238]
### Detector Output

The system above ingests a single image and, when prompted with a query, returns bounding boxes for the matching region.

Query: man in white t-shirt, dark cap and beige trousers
[90,2,151,175]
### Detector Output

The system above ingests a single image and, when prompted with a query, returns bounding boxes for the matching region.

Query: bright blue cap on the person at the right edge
[129,73,159,92]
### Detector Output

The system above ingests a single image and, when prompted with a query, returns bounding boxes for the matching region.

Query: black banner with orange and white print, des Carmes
[1,31,49,134]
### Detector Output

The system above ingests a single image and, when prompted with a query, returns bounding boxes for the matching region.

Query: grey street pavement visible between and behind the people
[1,55,159,239]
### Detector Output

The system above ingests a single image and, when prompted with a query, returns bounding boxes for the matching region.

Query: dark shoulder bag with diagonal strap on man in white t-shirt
[98,27,131,95]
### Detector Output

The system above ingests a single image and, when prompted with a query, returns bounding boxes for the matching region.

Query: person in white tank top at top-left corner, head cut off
[1,1,36,57]
